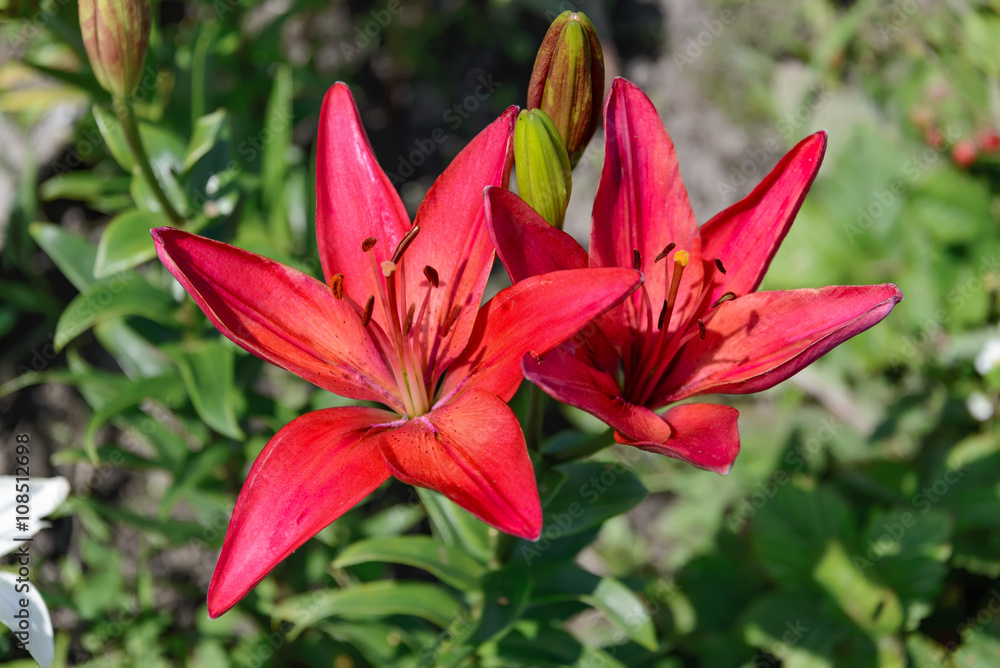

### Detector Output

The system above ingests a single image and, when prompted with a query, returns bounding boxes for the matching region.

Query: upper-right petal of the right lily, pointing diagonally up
[701,132,826,301]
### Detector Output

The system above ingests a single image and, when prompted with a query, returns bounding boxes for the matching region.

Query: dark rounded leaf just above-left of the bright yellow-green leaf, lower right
[751,483,854,583]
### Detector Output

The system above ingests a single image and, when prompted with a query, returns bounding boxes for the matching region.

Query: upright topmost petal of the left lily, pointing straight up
[316,83,410,328]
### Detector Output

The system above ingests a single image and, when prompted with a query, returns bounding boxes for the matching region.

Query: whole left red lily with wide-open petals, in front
[153,84,642,617]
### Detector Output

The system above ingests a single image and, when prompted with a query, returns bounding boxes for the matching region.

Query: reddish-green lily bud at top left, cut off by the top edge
[80,0,150,97]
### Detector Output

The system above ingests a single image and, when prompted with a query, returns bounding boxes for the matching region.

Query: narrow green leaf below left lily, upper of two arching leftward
[333,536,485,591]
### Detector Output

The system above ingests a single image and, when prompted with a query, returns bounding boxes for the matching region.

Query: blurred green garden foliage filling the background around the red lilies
[0,0,1000,668]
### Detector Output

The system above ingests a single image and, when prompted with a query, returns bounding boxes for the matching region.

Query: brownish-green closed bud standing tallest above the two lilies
[528,11,604,167]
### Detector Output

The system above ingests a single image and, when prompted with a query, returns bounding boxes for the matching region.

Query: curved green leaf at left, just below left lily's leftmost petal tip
[55,271,176,350]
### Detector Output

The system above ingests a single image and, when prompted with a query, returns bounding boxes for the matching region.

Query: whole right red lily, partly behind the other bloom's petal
[487,78,903,473]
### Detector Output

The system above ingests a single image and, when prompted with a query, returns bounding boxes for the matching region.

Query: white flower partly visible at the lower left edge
[0,475,69,668]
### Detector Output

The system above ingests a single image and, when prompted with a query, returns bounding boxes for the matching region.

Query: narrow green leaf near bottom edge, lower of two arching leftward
[271,580,461,639]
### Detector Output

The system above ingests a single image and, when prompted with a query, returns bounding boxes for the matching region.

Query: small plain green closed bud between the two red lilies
[514,109,573,229]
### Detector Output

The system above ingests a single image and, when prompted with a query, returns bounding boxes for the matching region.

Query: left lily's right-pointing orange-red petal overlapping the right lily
[438,268,642,400]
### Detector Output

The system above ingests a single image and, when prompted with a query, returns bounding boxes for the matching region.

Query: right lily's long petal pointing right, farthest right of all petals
[655,283,903,406]
